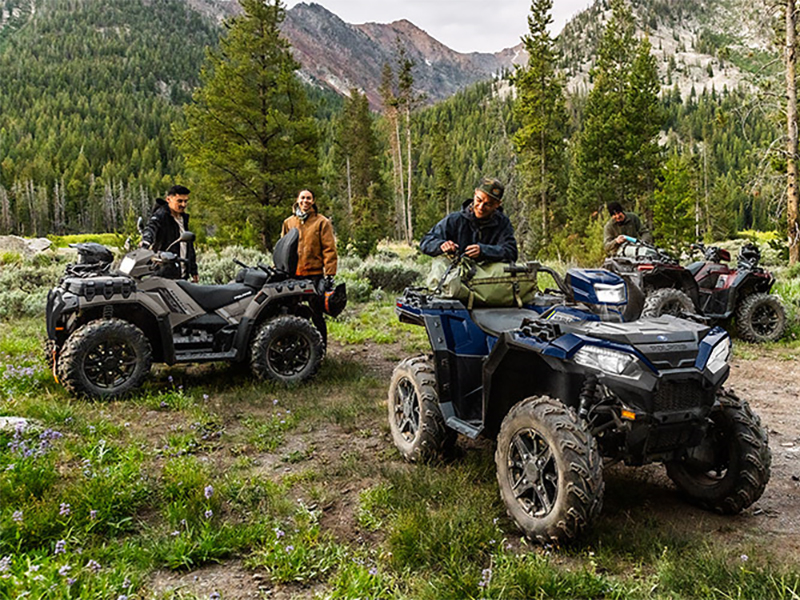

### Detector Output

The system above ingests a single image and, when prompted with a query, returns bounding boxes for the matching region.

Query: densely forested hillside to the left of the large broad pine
[0,0,217,235]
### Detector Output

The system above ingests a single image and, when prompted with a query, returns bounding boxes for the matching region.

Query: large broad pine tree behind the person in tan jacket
[177,0,318,246]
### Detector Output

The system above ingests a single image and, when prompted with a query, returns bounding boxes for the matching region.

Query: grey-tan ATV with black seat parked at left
[47,230,346,398]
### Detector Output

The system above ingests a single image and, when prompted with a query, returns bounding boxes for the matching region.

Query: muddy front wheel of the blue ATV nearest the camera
[495,396,604,544]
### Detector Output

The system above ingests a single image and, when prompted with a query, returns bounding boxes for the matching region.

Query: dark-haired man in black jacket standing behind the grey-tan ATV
[141,185,197,283]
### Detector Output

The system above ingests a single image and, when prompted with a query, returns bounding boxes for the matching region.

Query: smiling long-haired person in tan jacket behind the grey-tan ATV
[281,190,339,279]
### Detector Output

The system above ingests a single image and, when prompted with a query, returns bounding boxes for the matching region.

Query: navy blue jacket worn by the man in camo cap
[419,199,517,262]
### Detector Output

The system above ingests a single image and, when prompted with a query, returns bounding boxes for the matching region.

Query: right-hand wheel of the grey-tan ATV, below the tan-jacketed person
[250,315,325,383]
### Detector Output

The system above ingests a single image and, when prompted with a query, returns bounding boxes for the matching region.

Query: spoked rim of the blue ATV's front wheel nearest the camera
[508,429,558,518]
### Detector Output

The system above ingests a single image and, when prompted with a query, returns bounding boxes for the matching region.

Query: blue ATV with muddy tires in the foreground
[388,263,771,544]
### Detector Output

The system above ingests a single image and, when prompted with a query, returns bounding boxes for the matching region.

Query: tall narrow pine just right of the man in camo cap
[513,0,567,251]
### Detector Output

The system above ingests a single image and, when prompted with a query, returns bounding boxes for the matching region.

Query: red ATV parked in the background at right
[603,238,786,342]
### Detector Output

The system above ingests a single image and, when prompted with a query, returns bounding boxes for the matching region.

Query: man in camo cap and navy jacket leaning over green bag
[419,177,517,262]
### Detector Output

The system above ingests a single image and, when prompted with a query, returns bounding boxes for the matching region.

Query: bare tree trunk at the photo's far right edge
[786,0,800,265]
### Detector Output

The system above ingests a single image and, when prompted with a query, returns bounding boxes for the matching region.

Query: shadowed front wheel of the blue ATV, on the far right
[666,390,772,515]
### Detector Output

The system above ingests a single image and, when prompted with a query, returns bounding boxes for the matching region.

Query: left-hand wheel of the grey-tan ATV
[57,319,152,398]
